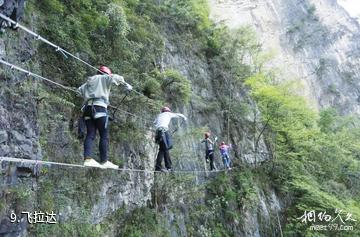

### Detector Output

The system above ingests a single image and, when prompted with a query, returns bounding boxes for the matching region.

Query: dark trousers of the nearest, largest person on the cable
[84,108,109,162]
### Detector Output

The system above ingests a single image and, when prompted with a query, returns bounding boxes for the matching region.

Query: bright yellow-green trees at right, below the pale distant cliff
[246,65,359,236]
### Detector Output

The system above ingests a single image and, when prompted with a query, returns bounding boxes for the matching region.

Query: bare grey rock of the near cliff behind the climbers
[0,1,280,236]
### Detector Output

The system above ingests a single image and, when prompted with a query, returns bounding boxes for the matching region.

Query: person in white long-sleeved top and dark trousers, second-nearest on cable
[154,107,187,172]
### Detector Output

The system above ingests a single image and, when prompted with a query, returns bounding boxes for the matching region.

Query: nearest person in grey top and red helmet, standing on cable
[78,66,132,169]
